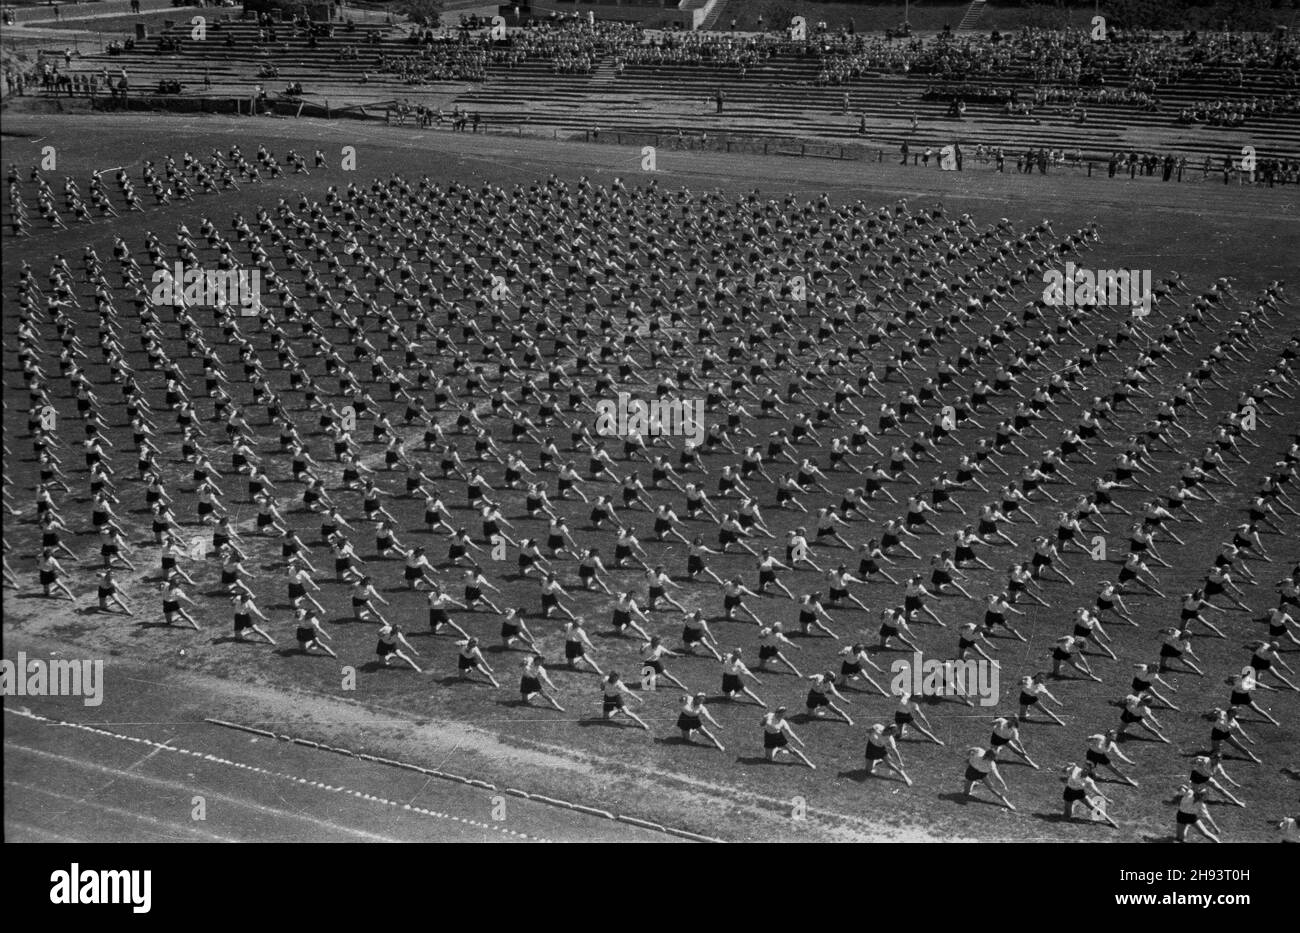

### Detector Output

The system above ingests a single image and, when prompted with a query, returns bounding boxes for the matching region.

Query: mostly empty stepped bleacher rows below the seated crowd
[50,19,1300,159]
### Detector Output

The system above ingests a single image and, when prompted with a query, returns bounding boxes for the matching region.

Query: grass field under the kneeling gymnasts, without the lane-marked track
[0,116,1300,841]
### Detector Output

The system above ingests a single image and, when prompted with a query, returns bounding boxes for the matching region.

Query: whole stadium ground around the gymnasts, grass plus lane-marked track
[0,114,1300,842]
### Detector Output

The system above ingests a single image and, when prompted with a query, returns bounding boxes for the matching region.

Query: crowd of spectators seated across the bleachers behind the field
[7,14,1300,151]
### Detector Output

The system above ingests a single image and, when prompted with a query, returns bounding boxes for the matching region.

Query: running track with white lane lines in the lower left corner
[4,697,675,842]
